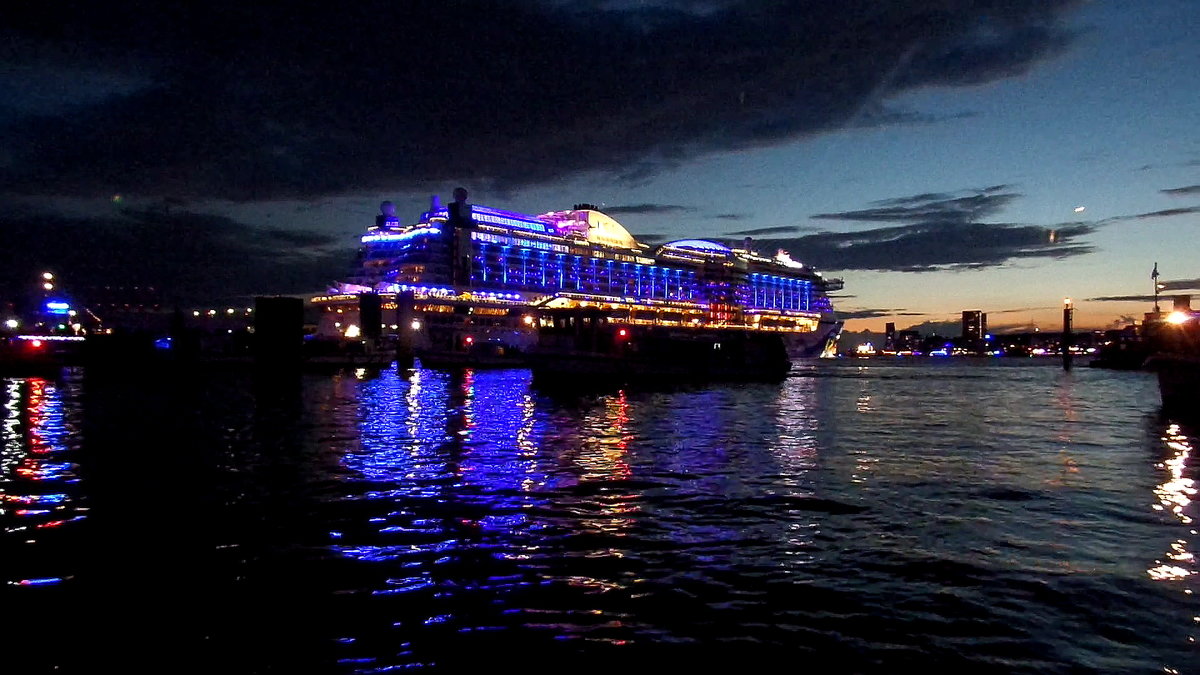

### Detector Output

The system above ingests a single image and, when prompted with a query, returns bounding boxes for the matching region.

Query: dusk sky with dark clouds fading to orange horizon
[0,0,1200,330]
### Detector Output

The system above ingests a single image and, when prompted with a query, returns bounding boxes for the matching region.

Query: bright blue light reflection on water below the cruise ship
[332,370,551,566]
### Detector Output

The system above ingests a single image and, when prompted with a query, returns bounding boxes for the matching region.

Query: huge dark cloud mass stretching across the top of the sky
[0,0,1078,199]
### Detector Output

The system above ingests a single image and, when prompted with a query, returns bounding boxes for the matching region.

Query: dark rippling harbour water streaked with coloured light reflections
[0,360,1200,674]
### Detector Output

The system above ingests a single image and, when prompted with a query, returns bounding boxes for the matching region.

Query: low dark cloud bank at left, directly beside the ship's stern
[0,210,353,305]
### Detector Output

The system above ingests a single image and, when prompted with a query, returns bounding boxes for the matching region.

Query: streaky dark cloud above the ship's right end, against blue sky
[757,185,1098,271]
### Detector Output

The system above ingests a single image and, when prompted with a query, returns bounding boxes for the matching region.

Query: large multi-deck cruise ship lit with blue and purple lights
[312,197,842,362]
